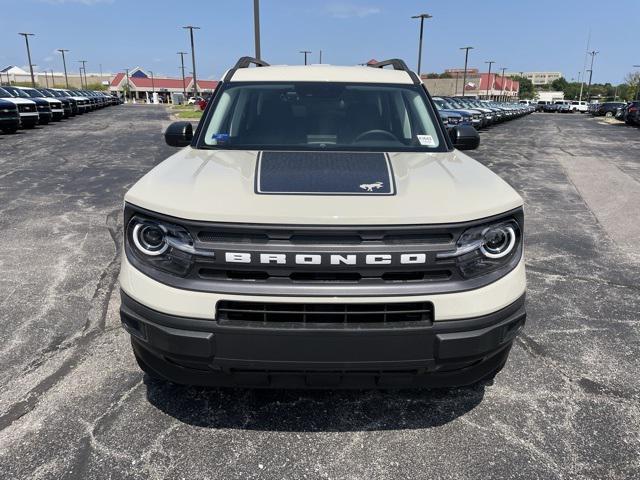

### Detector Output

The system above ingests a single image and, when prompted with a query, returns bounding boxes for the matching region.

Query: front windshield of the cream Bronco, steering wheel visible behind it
[204,82,446,151]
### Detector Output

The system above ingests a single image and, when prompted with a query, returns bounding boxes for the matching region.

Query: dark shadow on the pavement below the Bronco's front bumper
[144,375,490,432]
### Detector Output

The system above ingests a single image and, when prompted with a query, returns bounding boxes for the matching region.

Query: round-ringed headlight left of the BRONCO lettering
[125,215,214,276]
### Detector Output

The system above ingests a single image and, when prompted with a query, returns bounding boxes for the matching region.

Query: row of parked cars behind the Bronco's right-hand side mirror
[433,97,533,130]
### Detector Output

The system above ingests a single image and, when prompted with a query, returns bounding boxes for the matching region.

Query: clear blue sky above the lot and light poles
[0,0,640,83]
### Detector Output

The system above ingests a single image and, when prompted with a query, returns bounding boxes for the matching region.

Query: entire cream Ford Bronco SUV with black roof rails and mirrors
[120,57,525,388]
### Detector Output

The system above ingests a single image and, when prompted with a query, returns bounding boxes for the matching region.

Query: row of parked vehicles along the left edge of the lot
[0,85,122,133]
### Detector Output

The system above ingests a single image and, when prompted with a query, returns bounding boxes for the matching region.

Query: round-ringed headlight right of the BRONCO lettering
[436,219,522,278]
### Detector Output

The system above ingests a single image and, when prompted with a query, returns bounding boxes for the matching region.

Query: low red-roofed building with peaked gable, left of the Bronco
[109,67,218,101]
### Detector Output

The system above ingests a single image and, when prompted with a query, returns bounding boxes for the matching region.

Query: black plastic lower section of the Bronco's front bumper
[120,292,526,388]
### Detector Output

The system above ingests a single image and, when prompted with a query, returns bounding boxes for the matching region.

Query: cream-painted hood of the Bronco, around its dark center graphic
[125,147,522,225]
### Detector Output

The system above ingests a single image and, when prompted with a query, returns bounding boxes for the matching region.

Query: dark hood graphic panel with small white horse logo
[256,151,396,195]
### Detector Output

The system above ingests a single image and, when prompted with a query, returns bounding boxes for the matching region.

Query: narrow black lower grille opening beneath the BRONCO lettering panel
[216,300,433,325]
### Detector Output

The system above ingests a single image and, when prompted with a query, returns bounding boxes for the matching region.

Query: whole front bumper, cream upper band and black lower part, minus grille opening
[120,249,526,388]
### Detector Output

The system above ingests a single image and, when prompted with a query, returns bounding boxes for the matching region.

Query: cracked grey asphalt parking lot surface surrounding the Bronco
[0,105,640,479]
